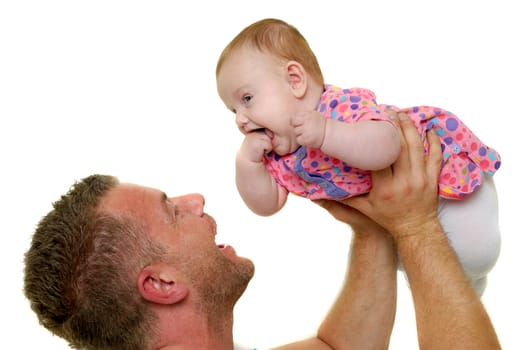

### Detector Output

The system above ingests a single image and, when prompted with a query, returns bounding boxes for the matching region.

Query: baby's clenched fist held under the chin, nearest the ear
[291,111,326,148]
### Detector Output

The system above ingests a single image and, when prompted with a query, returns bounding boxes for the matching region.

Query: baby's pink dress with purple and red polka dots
[264,85,501,199]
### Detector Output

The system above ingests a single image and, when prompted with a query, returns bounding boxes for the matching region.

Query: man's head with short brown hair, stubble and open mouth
[24,175,253,349]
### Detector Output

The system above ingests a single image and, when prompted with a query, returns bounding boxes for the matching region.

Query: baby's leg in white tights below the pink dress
[438,176,501,296]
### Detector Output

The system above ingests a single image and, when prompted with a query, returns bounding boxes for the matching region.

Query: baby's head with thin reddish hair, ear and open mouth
[216,19,324,154]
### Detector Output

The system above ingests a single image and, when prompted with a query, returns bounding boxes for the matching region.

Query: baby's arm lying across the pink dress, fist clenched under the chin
[292,111,401,170]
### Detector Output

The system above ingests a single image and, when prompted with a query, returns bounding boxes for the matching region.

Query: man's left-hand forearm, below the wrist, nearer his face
[318,229,397,350]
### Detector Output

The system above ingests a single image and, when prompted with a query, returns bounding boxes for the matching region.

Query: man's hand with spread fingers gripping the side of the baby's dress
[344,114,442,239]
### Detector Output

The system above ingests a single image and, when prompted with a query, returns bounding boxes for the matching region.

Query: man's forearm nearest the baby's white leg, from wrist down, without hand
[397,219,500,350]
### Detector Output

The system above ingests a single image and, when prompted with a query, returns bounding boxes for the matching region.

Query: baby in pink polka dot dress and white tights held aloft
[216,19,501,295]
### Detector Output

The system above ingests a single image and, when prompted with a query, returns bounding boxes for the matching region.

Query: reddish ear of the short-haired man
[137,263,189,304]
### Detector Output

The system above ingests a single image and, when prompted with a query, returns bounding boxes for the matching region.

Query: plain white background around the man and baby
[0,0,525,350]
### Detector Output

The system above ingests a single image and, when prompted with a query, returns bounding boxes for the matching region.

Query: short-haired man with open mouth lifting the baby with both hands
[24,114,499,350]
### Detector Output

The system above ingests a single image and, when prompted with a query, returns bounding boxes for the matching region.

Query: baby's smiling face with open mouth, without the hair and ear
[217,48,299,155]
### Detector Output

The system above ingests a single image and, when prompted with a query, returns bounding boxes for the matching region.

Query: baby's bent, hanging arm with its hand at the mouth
[235,132,288,216]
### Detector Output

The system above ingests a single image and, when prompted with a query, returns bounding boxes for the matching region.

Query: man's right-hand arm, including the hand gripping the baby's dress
[346,115,501,350]
